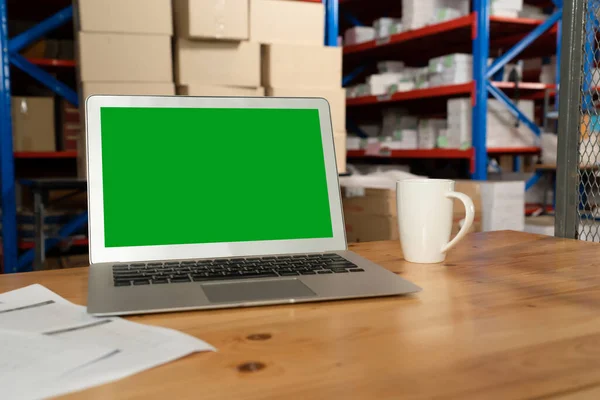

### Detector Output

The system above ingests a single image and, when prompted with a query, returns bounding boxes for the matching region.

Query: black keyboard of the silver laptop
[113,254,364,286]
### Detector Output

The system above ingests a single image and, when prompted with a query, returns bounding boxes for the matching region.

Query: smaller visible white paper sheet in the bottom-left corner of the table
[0,330,112,399]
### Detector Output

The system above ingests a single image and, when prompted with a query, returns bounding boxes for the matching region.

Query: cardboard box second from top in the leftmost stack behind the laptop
[78,32,173,82]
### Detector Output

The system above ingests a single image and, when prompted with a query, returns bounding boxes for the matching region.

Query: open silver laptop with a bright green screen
[86,95,420,315]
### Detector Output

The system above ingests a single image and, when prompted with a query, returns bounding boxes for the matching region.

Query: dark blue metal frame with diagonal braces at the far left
[0,0,81,273]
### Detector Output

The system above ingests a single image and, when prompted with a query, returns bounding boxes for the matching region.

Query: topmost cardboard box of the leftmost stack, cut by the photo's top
[77,0,173,36]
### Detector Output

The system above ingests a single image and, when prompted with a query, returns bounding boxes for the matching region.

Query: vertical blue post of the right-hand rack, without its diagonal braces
[472,0,490,180]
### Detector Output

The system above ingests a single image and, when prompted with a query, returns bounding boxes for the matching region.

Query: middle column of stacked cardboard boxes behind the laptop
[173,0,264,96]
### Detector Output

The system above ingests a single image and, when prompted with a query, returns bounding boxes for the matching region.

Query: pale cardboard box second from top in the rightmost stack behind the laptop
[262,44,342,89]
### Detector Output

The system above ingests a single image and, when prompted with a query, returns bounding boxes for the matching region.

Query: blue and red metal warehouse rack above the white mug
[340,0,562,181]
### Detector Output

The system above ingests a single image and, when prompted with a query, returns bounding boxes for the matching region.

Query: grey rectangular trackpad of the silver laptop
[202,279,315,303]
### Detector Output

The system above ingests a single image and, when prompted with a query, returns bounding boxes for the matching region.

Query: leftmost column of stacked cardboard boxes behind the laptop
[76,0,175,176]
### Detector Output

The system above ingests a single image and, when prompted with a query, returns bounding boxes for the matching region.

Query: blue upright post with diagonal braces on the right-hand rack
[472,0,562,178]
